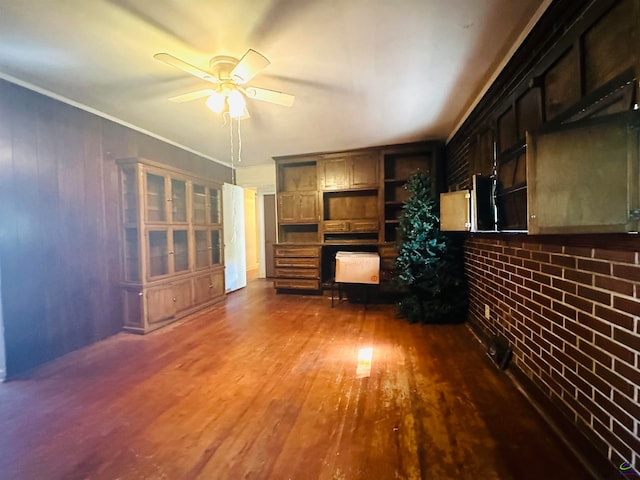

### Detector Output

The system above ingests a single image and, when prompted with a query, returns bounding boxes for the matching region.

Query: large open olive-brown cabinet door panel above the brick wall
[527,112,640,234]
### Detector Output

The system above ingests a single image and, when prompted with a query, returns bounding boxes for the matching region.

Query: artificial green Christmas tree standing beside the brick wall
[395,172,467,323]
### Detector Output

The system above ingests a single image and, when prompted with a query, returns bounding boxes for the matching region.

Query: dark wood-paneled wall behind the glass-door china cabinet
[0,80,230,377]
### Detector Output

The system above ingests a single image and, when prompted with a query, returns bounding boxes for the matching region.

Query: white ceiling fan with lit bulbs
[153,49,295,119]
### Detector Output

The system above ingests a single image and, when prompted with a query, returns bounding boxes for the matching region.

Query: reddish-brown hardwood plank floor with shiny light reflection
[0,280,590,480]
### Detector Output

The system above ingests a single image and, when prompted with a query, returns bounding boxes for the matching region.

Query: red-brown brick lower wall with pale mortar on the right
[465,235,640,466]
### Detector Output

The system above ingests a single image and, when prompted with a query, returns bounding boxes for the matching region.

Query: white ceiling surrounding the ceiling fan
[0,0,550,166]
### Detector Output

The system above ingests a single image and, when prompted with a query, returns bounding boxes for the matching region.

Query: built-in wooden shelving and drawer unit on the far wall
[274,142,443,292]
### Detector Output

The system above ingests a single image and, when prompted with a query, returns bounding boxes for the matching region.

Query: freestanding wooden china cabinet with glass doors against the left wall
[118,158,225,333]
